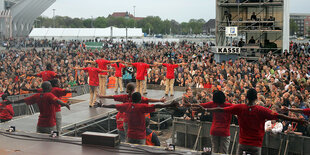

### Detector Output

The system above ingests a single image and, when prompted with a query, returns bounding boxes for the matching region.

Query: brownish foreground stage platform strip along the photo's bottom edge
[0,130,201,155]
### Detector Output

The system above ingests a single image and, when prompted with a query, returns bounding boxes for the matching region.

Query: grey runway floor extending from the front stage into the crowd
[0,89,183,134]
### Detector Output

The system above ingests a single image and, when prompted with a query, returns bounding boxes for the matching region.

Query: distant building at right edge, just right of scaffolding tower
[290,13,310,37]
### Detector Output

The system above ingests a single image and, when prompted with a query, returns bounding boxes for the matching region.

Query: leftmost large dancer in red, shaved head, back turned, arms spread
[6,81,70,134]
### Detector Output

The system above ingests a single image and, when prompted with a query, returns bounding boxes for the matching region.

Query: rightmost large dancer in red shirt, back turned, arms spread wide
[194,89,307,155]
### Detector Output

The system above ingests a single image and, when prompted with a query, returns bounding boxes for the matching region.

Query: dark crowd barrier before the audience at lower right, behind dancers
[172,118,310,155]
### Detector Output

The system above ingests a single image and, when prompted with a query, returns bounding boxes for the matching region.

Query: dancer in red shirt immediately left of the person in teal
[111,62,126,93]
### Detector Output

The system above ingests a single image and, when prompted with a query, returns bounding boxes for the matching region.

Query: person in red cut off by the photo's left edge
[0,94,14,123]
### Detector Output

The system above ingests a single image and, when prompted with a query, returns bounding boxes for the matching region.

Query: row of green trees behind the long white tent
[34,16,206,35]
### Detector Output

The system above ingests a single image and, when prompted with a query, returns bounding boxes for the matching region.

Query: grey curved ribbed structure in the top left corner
[0,0,56,38]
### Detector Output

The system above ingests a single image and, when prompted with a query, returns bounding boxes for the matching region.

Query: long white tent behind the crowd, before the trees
[29,27,143,40]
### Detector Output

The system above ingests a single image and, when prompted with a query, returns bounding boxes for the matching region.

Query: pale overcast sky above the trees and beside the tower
[43,0,310,22]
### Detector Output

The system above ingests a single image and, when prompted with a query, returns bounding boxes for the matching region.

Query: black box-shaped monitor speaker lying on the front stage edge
[82,131,120,147]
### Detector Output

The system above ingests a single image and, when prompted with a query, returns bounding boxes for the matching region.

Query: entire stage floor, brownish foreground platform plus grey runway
[0,90,191,155]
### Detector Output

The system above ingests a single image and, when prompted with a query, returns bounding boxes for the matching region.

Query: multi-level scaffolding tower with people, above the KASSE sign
[216,0,289,51]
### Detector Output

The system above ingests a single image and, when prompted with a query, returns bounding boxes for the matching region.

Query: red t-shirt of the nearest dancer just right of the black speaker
[116,103,155,139]
